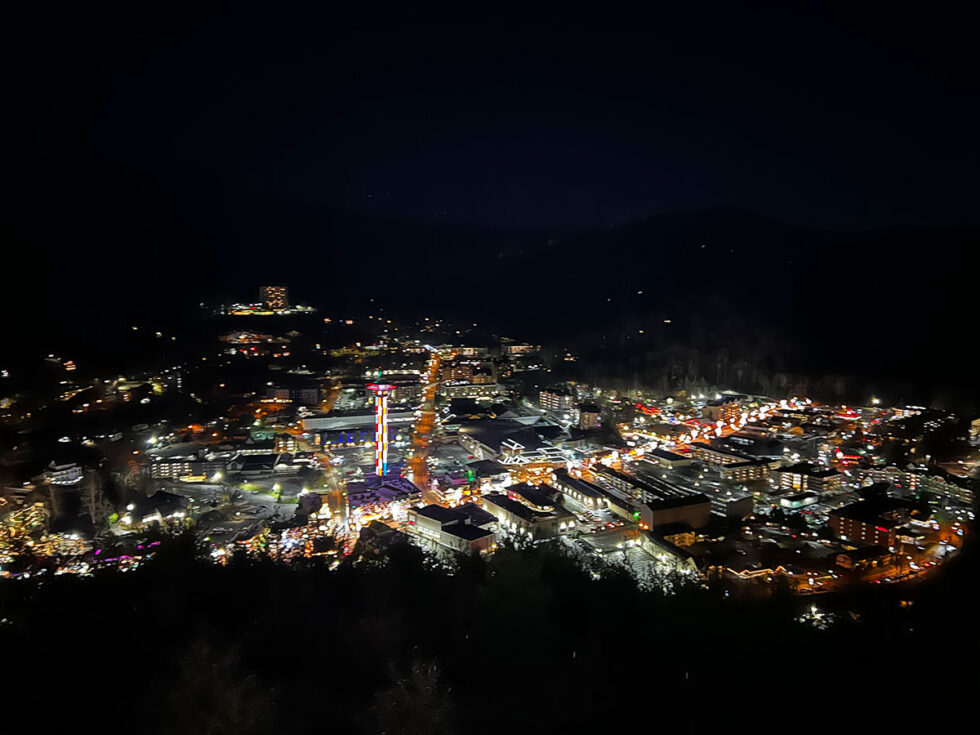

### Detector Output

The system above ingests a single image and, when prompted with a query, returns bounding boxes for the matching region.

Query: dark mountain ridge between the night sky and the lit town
[7,161,980,408]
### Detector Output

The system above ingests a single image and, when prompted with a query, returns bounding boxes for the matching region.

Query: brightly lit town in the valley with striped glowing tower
[0,287,980,595]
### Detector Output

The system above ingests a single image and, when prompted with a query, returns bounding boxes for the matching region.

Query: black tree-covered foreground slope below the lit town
[0,537,978,733]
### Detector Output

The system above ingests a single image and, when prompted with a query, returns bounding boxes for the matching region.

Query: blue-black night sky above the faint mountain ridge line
[11,3,980,229]
